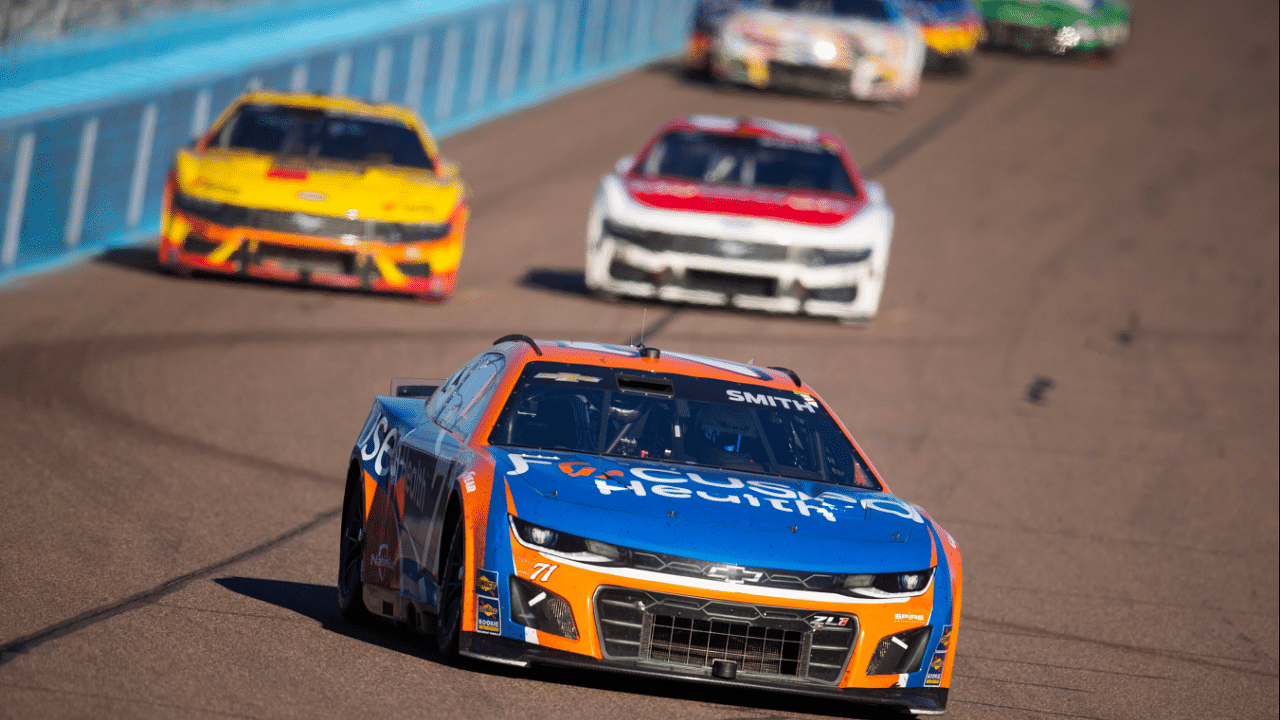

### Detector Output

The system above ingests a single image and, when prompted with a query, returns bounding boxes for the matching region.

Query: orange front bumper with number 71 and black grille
[460,530,955,714]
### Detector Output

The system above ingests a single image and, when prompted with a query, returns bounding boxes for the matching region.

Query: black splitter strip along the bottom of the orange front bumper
[460,633,947,715]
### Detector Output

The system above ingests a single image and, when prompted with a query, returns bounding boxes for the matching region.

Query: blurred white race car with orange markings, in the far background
[710,0,925,102]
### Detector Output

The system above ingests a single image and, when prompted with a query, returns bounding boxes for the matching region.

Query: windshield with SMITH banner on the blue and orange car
[489,363,881,489]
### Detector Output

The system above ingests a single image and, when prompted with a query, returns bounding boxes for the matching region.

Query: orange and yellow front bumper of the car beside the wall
[157,198,467,300]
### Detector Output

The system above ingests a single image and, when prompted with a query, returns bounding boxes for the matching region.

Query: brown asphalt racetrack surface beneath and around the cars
[0,0,1280,720]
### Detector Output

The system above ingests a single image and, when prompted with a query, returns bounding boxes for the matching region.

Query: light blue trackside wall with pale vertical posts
[0,0,694,283]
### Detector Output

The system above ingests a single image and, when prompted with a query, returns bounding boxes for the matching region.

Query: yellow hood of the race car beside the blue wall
[175,150,462,223]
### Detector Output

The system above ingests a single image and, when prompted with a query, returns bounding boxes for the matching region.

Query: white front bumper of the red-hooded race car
[588,236,884,319]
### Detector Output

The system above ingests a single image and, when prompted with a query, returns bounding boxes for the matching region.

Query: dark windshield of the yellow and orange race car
[212,104,434,170]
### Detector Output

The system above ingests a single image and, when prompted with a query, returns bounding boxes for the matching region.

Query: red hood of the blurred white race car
[623,178,867,225]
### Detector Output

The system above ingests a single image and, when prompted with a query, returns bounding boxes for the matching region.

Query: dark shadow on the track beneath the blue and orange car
[214,577,908,720]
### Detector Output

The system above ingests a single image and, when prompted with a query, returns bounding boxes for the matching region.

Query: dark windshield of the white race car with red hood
[637,131,856,195]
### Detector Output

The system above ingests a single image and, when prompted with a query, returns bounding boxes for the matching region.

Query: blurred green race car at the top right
[982,0,1130,55]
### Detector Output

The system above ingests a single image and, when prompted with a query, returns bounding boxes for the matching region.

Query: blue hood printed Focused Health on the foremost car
[493,448,932,573]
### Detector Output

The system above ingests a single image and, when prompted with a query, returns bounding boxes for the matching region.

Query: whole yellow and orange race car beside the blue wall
[159,91,468,300]
